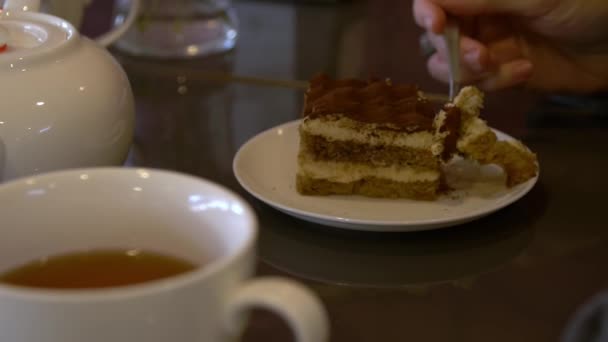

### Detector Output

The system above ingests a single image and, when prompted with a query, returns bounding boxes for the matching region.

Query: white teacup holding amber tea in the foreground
[0,168,328,342]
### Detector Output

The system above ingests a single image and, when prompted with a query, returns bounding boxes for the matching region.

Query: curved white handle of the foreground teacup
[224,277,329,342]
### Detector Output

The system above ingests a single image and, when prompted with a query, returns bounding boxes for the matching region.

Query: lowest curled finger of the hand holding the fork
[478,59,534,91]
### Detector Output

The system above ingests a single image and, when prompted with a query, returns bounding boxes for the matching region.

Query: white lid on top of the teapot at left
[0,9,78,65]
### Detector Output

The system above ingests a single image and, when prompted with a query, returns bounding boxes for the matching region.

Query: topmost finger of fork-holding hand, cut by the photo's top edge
[432,0,551,16]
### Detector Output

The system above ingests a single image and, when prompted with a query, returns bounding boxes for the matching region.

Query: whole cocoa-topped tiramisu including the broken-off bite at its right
[296,75,536,200]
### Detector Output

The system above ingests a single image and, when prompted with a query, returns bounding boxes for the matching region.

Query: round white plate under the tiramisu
[232,120,538,231]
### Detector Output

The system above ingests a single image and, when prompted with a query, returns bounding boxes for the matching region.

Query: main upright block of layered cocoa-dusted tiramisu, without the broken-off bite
[297,75,459,199]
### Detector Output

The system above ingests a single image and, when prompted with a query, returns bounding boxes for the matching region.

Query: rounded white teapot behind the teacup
[0,0,139,182]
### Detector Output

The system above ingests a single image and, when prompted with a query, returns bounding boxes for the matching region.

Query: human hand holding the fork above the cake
[413,0,608,93]
